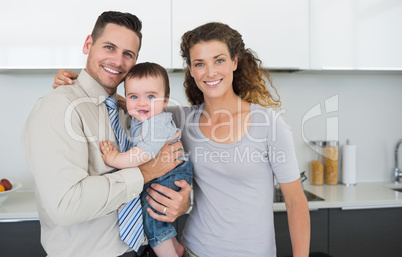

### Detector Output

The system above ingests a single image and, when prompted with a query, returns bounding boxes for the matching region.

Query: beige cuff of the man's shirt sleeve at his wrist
[119,168,144,201]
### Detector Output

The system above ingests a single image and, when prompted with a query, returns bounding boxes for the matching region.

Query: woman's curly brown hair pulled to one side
[180,22,281,108]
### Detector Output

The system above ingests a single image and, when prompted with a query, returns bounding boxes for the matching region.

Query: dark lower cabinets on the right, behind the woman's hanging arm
[274,208,402,257]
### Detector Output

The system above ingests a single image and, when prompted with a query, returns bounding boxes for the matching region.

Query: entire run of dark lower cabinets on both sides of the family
[0,208,402,257]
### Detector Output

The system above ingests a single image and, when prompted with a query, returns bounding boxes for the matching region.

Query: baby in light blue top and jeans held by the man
[101,62,193,257]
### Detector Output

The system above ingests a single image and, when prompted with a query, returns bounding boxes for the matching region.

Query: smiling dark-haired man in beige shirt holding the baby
[22,12,191,257]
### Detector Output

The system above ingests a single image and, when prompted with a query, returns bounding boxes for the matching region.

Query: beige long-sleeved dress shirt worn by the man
[22,70,144,257]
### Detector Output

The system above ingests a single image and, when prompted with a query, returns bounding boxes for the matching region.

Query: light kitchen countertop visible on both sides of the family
[0,182,402,219]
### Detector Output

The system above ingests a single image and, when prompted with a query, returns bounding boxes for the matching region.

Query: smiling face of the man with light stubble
[83,23,140,94]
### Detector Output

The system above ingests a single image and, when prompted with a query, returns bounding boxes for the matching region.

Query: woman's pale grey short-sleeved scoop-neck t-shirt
[167,104,300,257]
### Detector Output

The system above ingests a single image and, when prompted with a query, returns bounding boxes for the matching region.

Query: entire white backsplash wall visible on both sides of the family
[0,72,402,184]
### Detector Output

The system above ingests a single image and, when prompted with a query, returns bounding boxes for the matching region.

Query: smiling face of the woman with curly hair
[189,40,237,99]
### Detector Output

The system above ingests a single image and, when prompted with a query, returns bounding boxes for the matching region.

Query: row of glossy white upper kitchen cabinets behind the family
[0,0,402,70]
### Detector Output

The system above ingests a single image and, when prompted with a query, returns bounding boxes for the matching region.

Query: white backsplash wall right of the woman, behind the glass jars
[274,72,402,182]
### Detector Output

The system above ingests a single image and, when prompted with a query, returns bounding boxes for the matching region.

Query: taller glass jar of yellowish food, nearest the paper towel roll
[324,141,338,185]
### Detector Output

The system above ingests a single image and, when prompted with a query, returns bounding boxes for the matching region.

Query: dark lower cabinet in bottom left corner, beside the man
[0,218,46,257]
